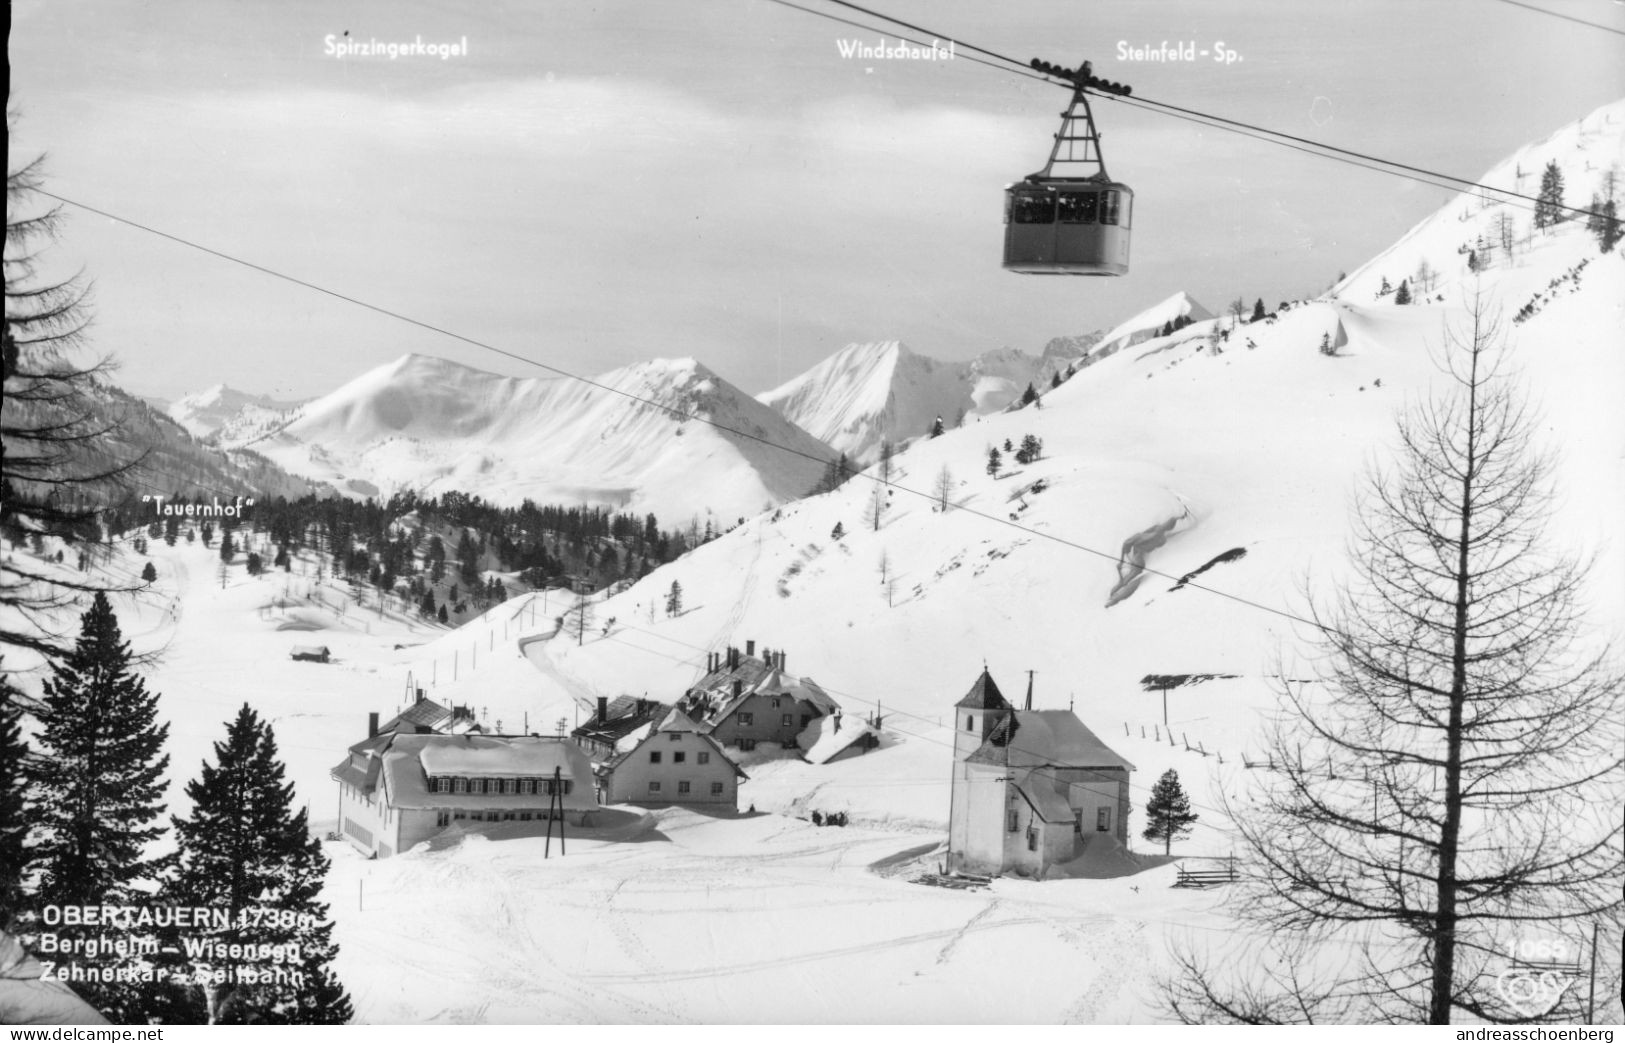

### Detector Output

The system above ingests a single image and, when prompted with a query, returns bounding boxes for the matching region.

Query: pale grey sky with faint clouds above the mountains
[10,0,1625,400]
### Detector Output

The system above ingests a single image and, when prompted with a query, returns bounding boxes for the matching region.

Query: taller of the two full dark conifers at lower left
[26,593,169,1024]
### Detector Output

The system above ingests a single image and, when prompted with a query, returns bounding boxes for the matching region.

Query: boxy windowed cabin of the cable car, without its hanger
[1004,180,1134,275]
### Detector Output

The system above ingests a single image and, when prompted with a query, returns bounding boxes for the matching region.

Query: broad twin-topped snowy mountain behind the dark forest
[252,354,834,525]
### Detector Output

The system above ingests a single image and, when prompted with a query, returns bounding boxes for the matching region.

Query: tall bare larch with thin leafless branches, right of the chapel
[1164,297,1625,1024]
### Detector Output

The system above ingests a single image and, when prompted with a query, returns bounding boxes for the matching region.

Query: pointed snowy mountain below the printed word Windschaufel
[757,341,1081,465]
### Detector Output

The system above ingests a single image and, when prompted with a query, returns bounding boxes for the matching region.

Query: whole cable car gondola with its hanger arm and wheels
[1004,58,1134,275]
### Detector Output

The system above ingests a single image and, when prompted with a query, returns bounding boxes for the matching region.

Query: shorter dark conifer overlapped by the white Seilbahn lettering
[169,703,353,1025]
